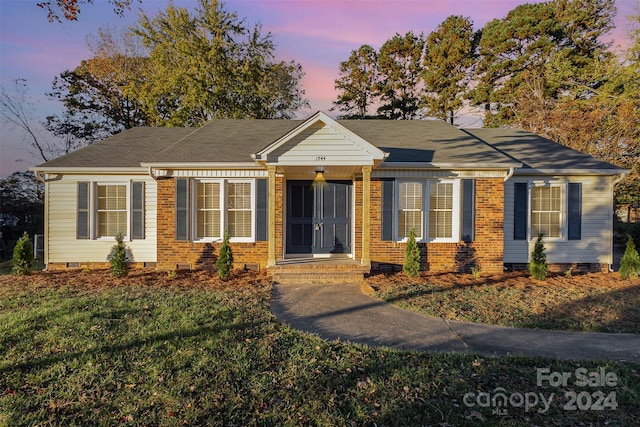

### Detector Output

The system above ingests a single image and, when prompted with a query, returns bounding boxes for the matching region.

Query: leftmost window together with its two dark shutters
[76,181,145,240]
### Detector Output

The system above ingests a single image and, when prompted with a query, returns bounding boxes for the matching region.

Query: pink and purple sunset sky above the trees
[0,0,638,179]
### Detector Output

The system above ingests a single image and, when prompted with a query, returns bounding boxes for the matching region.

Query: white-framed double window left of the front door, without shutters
[193,180,254,241]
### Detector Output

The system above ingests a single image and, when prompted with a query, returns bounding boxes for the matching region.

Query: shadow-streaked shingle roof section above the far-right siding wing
[466,128,622,171]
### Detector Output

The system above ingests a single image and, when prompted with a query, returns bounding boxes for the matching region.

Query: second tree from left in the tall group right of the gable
[375,31,425,120]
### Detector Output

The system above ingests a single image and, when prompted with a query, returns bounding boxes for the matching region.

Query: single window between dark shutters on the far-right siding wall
[531,185,562,238]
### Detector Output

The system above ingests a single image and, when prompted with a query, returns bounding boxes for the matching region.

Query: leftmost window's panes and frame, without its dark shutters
[96,185,128,238]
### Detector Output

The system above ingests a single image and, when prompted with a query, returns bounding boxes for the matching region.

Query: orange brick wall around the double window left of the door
[156,179,267,270]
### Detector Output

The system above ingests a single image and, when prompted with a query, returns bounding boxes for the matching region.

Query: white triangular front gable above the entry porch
[252,112,387,167]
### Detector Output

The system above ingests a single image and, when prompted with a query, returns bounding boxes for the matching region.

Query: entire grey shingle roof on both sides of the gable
[38,120,617,170]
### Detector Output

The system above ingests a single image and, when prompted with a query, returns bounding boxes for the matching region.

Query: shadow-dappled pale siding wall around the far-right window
[504,176,613,264]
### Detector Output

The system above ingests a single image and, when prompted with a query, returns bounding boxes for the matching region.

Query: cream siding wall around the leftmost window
[45,175,157,263]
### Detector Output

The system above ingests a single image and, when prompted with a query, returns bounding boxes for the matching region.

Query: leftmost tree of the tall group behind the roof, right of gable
[331,44,378,118]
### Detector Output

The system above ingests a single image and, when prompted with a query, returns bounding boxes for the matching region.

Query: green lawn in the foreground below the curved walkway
[0,272,640,426]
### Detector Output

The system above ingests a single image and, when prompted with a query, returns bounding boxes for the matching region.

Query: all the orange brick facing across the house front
[48,175,504,273]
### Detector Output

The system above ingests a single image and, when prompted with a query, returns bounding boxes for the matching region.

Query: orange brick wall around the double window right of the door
[368,178,504,273]
